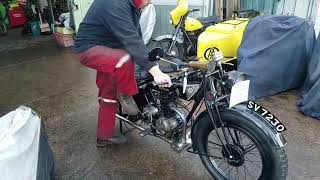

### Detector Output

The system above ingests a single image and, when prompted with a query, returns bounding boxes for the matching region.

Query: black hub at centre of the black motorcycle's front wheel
[222,144,244,167]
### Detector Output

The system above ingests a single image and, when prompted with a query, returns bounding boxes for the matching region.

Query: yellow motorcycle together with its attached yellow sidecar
[154,0,259,64]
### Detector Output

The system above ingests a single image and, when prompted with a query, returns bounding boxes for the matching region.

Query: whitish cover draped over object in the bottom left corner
[0,106,54,180]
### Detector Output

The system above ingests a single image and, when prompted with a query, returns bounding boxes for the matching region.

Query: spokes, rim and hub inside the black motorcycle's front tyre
[206,127,264,179]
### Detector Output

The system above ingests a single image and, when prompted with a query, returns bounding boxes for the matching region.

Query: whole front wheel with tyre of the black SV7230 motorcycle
[195,112,288,180]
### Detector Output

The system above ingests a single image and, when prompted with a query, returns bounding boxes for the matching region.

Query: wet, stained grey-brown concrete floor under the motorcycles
[0,31,320,180]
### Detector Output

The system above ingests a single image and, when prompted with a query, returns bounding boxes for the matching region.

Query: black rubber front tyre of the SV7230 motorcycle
[195,112,288,180]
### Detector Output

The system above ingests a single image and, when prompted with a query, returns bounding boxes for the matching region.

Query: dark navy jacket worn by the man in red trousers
[75,0,154,71]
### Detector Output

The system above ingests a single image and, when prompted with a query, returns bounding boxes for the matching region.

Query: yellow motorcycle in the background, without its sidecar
[155,0,220,59]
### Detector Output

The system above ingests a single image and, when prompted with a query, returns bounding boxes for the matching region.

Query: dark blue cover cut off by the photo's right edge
[298,32,320,119]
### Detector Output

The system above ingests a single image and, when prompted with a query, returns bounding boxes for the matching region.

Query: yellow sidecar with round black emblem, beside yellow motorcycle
[197,18,249,62]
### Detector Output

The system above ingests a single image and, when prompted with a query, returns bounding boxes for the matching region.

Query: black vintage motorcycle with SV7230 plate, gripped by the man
[117,48,288,180]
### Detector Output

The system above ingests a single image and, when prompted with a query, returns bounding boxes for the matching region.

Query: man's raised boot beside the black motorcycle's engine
[117,92,139,115]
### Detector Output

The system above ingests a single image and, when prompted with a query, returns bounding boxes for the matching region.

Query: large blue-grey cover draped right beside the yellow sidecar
[238,16,315,99]
